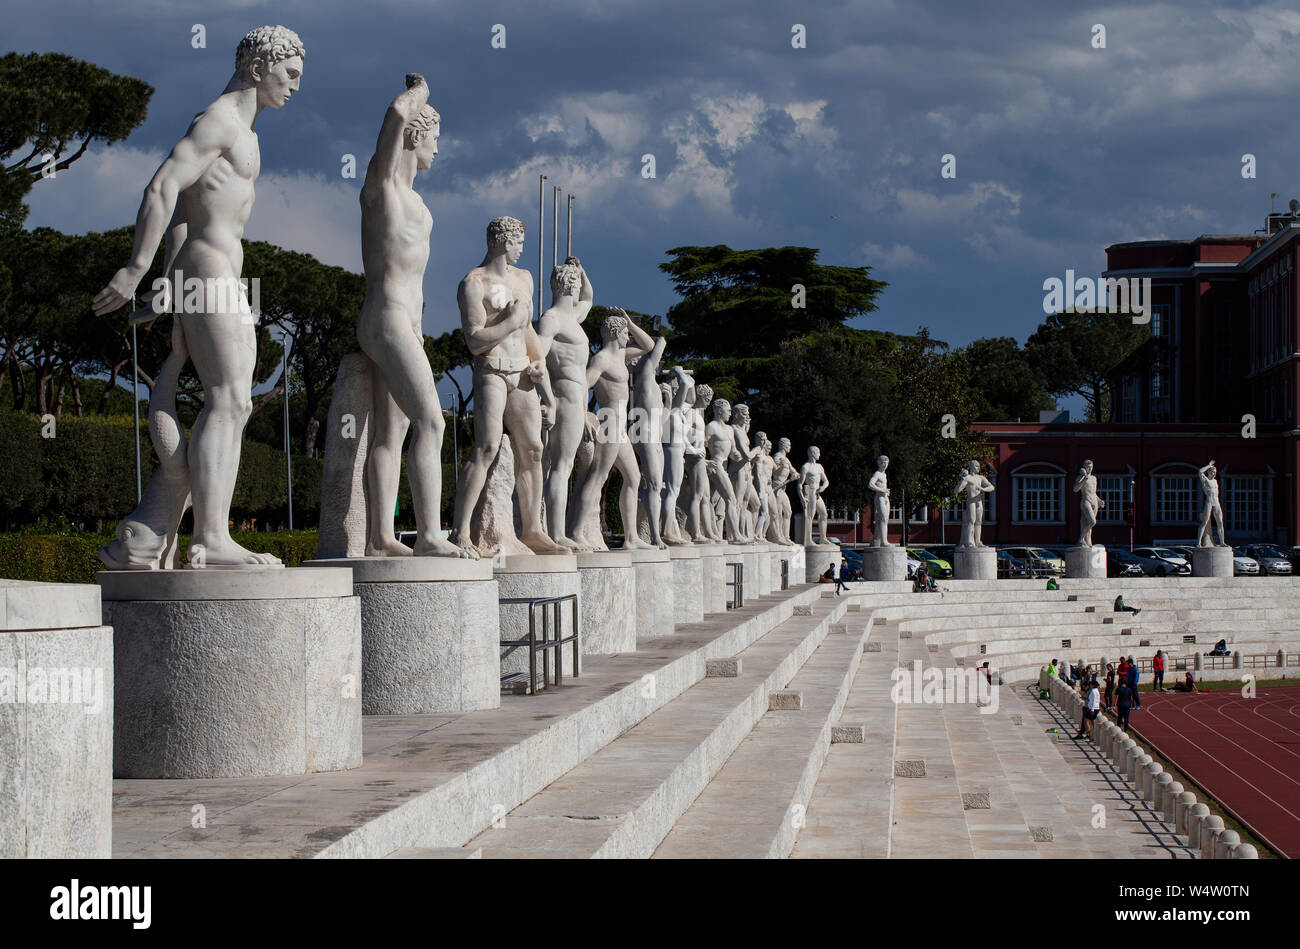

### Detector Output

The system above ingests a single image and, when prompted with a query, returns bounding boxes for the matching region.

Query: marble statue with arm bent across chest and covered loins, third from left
[451,217,566,555]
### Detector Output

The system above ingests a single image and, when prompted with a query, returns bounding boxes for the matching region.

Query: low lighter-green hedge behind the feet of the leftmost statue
[0,530,316,584]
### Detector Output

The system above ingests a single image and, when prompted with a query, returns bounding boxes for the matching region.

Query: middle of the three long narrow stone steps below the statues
[654,613,871,859]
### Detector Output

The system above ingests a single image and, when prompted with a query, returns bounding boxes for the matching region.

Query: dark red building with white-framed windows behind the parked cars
[831,213,1300,546]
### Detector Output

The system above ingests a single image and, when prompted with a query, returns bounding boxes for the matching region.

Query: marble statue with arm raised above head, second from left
[356,79,468,556]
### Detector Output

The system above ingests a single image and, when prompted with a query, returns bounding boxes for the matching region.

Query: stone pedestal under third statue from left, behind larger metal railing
[493,554,584,688]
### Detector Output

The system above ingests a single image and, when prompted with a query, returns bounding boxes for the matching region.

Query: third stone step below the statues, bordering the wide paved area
[790,624,900,859]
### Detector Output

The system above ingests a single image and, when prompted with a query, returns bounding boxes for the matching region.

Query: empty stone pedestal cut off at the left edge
[0,580,113,859]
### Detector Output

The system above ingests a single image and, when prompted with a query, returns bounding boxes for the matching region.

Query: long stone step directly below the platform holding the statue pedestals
[469,599,845,859]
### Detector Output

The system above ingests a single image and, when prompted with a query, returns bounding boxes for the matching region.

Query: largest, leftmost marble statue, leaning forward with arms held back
[91,26,307,569]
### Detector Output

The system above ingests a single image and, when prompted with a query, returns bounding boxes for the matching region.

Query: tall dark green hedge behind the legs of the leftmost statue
[0,411,321,529]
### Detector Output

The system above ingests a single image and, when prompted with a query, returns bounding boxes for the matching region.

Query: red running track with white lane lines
[1130,685,1300,857]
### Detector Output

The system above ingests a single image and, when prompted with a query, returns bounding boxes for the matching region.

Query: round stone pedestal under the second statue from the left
[303,556,501,715]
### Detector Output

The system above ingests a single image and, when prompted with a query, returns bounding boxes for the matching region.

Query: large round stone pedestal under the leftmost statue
[99,567,361,777]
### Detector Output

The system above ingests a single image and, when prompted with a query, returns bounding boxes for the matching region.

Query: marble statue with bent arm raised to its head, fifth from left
[569,307,655,550]
